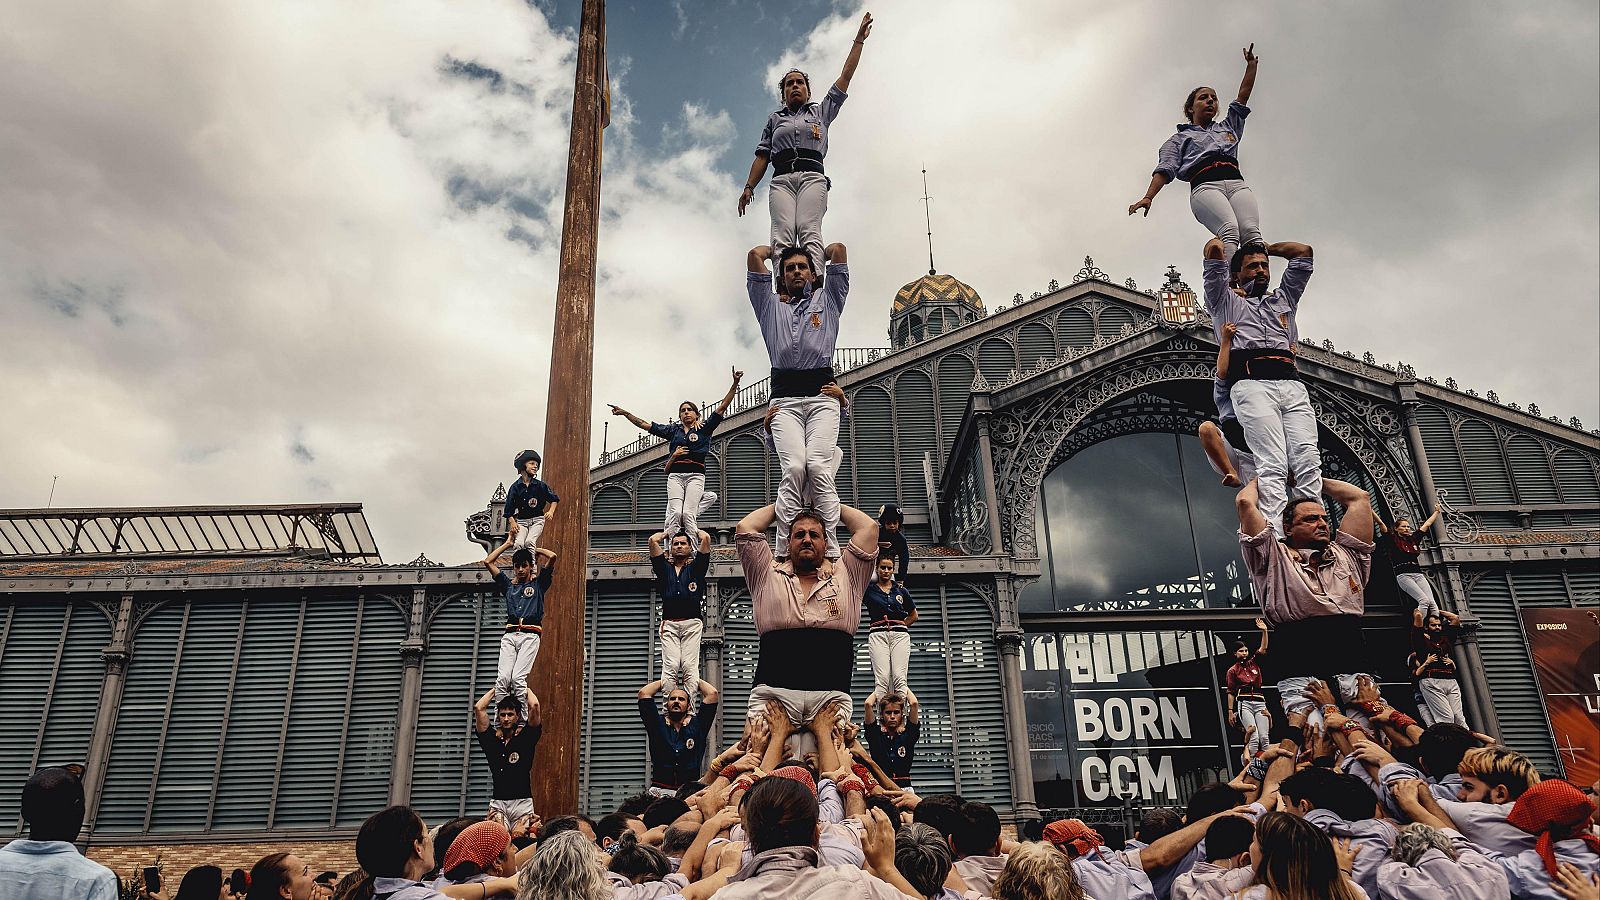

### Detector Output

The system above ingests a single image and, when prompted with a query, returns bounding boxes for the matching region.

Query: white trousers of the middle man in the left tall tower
[773,394,843,559]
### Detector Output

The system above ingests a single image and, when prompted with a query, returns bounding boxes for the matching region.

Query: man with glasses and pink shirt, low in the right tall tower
[1235,479,1384,746]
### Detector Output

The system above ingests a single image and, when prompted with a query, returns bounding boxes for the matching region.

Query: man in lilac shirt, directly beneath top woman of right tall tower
[1205,237,1322,536]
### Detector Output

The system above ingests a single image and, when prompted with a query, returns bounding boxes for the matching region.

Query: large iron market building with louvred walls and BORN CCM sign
[0,261,1600,847]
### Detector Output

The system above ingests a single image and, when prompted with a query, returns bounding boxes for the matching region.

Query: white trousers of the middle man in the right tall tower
[1229,378,1322,538]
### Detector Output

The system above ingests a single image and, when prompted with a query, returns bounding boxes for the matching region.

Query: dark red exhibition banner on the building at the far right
[1522,609,1600,785]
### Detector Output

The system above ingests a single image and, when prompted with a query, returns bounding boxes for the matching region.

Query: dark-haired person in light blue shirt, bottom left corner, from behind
[0,765,120,900]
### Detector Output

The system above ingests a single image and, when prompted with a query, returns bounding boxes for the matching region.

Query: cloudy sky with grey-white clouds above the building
[0,0,1600,562]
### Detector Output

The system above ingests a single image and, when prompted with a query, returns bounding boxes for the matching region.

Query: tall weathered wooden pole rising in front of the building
[533,0,606,820]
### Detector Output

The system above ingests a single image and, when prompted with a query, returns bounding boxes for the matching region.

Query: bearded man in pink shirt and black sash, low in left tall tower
[734,493,878,756]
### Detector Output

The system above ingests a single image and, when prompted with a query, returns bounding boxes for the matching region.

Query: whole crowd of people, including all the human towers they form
[0,14,1600,900]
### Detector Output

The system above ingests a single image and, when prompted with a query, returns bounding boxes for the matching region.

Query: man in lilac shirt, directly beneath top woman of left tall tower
[746,243,851,557]
